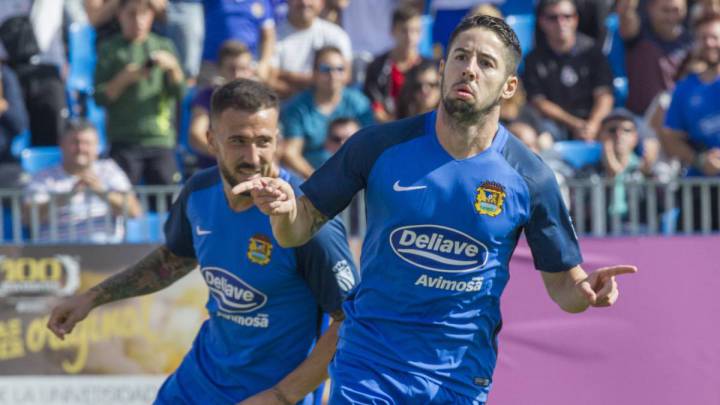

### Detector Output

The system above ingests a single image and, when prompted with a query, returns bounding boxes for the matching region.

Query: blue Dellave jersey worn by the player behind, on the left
[159,167,356,404]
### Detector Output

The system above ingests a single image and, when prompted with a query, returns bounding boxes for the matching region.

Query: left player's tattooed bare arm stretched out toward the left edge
[47,246,197,339]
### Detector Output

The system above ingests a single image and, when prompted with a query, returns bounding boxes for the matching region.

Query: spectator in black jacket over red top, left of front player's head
[363,6,425,122]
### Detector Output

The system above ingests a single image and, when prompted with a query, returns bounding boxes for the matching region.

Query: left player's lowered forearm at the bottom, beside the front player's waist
[240,311,345,405]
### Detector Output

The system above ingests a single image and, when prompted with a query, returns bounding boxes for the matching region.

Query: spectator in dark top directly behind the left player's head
[189,39,256,168]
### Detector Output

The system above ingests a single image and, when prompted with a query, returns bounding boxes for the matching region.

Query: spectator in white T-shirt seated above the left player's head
[270,0,352,98]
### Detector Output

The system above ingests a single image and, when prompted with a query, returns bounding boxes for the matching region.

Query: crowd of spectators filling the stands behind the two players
[0,0,720,240]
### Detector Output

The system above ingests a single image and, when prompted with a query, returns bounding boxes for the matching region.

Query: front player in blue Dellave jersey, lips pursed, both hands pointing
[234,16,637,405]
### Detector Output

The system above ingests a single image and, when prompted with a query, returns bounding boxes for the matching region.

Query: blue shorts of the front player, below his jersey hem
[329,353,484,405]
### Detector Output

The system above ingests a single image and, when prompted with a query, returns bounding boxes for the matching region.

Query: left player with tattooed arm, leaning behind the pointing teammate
[48,79,356,405]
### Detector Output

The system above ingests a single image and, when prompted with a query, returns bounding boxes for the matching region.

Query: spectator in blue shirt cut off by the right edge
[660,14,720,230]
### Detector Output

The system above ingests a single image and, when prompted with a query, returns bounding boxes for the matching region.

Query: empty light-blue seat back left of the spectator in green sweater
[67,23,97,92]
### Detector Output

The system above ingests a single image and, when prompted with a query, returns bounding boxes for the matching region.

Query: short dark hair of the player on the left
[210,79,280,117]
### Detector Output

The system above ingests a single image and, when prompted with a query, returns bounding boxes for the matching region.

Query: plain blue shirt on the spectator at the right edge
[665,75,720,176]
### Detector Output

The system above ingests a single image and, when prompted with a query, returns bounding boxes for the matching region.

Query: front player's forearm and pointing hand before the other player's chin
[233,177,328,248]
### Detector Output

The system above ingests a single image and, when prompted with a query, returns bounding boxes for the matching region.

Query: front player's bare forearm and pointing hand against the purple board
[542,265,637,313]
